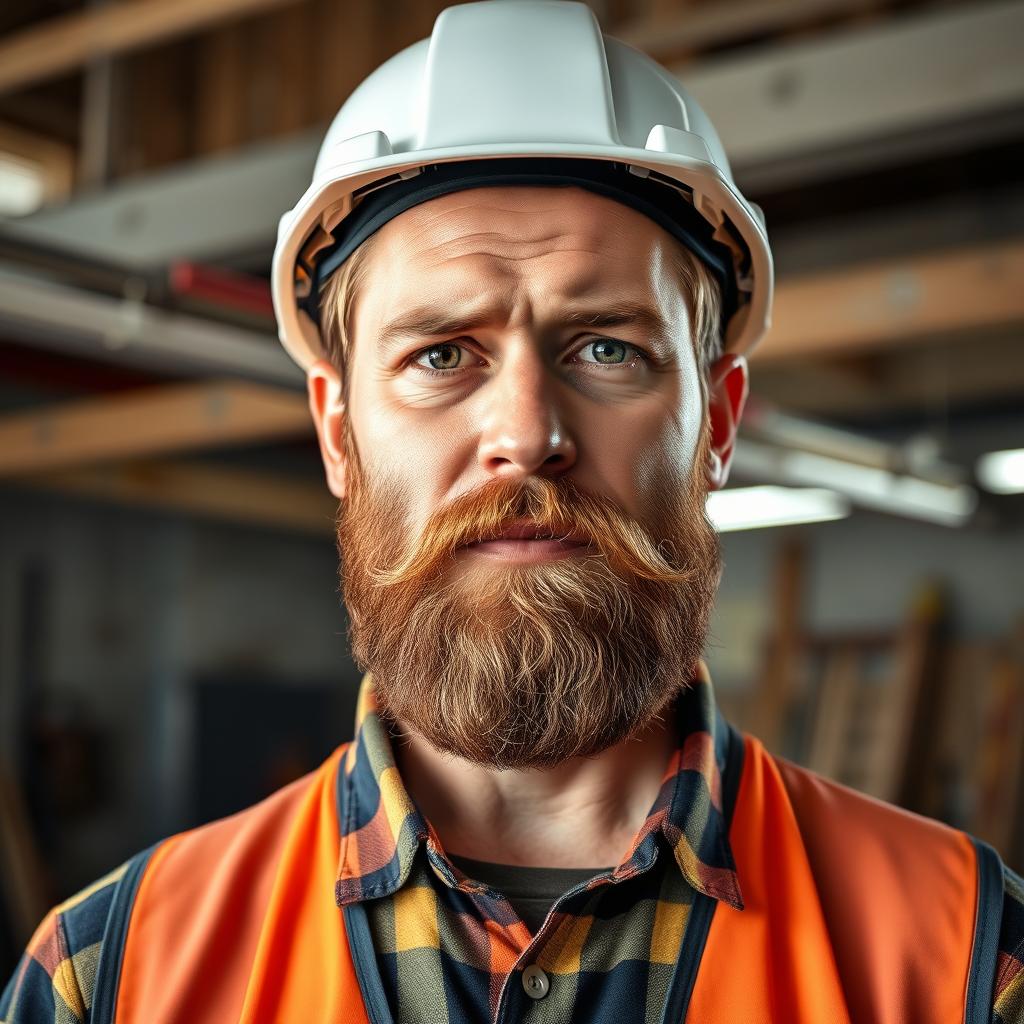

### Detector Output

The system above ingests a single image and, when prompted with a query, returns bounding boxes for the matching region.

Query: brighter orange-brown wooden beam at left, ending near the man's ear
[0,382,312,477]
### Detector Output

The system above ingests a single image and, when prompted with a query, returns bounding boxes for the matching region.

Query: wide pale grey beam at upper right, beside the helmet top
[670,0,1024,174]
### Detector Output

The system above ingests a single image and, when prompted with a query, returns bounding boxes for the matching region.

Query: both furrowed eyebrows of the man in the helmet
[377,302,671,350]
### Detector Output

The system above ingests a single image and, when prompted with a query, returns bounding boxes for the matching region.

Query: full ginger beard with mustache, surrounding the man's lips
[337,428,721,770]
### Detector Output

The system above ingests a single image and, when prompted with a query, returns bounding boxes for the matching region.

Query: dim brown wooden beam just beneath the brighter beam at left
[18,461,338,537]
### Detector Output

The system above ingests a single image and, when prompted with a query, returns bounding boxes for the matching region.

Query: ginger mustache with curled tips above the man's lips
[370,468,702,588]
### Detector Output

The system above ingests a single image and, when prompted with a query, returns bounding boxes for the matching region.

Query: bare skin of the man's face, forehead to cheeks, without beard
[349,186,703,528]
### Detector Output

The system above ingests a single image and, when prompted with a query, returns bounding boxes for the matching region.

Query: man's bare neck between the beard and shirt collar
[394,712,677,867]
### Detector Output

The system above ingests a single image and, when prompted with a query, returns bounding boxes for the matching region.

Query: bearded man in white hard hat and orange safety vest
[0,2,1024,1024]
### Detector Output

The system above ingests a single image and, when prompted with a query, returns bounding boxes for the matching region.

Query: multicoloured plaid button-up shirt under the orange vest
[0,666,1024,1024]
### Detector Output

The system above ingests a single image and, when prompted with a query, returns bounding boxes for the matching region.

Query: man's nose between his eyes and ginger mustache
[478,349,577,477]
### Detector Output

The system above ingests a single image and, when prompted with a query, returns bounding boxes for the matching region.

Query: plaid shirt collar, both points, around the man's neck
[335,662,743,910]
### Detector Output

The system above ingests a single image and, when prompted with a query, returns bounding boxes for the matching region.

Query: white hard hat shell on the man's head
[271,0,773,368]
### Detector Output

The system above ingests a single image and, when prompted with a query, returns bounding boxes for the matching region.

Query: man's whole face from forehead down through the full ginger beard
[310,186,741,768]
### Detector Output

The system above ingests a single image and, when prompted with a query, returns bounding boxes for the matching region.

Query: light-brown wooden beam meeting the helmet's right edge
[754,239,1024,364]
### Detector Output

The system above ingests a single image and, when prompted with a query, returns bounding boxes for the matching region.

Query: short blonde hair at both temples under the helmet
[321,236,722,395]
